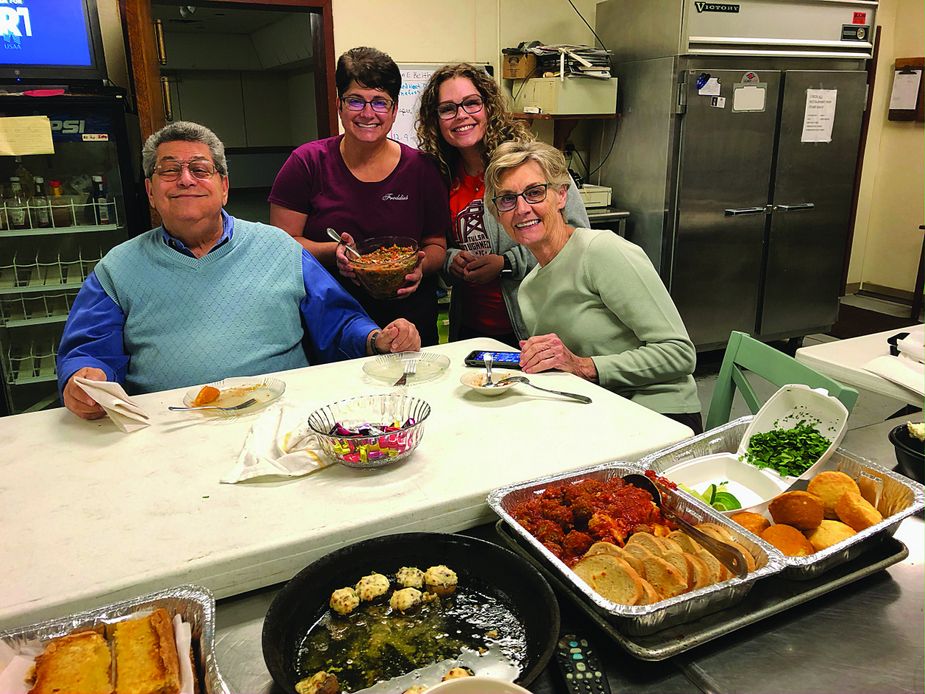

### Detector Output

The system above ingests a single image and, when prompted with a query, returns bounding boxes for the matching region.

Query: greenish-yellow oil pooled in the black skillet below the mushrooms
[296,585,527,692]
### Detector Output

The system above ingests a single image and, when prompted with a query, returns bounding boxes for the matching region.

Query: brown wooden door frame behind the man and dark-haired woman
[119,0,337,141]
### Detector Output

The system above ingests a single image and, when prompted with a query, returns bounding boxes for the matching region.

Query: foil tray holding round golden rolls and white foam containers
[639,416,925,580]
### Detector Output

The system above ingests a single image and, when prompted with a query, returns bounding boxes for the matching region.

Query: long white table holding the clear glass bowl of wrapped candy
[0,340,691,628]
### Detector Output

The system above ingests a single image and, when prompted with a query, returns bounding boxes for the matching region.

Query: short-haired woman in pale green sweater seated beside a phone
[485,141,702,433]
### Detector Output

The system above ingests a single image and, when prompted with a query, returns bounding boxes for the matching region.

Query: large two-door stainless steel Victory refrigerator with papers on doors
[596,0,877,350]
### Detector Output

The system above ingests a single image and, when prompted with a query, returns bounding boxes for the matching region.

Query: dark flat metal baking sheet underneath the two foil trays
[495,520,909,660]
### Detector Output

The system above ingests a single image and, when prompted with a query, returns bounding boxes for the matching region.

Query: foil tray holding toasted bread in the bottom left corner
[0,585,231,694]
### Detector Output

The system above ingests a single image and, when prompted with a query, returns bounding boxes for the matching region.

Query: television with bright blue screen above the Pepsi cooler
[0,0,106,84]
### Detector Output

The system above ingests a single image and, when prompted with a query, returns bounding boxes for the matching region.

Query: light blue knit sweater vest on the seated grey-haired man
[95,219,308,392]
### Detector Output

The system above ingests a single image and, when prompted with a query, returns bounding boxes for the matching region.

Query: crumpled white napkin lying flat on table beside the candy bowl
[220,405,333,484]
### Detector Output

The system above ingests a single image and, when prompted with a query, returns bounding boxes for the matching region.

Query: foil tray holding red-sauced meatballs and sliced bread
[488,462,783,634]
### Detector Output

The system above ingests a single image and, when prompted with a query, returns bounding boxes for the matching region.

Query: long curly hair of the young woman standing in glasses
[415,63,533,183]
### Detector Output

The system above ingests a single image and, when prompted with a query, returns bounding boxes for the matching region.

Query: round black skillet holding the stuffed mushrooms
[263,533,559,694]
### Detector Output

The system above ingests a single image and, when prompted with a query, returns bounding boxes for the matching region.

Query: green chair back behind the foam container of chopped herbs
[705,330,858,429]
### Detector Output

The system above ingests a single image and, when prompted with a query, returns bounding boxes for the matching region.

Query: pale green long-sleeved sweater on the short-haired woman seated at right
[519,229,700,414]
